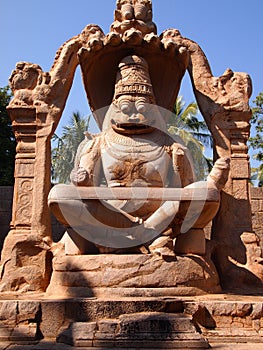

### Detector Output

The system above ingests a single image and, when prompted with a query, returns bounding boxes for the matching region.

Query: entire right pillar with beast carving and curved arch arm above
[169,32,261,291]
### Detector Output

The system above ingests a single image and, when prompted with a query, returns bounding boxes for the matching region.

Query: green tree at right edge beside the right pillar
[249,92,263,186]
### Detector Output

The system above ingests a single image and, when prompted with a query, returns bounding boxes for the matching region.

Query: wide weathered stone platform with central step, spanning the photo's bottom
[0,293,263,350]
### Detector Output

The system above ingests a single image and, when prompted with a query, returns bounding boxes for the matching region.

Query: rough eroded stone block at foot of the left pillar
[0,229,52,293]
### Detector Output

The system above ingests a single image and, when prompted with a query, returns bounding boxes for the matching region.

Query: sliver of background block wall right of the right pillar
[250,187,263,251]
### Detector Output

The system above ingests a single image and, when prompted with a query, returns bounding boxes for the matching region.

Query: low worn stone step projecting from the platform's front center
[57,312,209,349]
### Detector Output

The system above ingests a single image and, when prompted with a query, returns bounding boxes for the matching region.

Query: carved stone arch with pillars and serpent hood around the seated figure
[0,0,258,291]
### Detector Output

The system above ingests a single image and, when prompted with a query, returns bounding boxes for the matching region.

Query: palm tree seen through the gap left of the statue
[52,112,90,183]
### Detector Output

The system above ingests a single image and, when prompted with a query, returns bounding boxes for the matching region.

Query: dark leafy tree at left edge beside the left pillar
[0,86,16,186]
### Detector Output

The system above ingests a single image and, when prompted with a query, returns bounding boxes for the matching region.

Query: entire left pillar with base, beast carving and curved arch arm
[0,31,82,291]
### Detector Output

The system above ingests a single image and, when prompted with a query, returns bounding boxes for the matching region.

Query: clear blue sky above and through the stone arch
[0,0,263,142]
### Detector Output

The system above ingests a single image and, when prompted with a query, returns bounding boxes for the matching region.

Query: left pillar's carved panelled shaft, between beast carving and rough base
[4,107,54,238]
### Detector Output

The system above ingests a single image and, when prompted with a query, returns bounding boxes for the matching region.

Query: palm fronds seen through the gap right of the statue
[167,96,213,180]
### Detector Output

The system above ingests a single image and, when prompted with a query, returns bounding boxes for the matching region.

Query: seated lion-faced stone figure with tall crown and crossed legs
[49,55,229,255]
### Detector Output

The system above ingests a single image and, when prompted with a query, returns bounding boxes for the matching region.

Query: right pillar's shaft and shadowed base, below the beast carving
[211,112,261,292]
